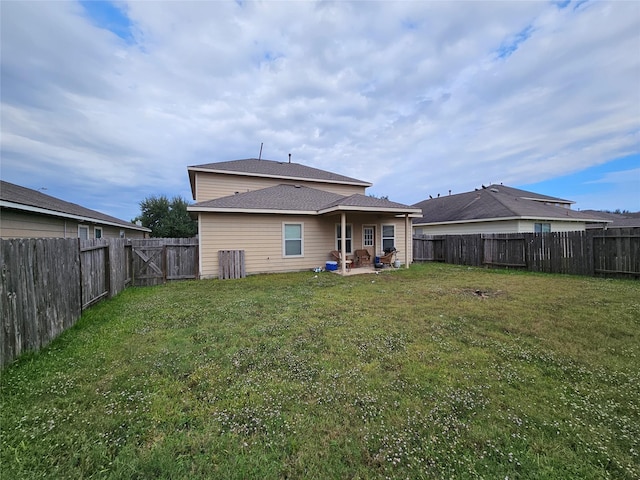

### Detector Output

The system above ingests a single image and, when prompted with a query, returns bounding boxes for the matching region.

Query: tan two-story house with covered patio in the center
[188,159,420,278]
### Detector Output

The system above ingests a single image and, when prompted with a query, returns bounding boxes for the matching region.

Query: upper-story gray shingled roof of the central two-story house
[187,158,371,187]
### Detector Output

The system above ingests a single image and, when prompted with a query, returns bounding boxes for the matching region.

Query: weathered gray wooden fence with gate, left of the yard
[0,238,198,367]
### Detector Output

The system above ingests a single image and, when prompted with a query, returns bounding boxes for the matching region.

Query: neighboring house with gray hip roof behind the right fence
[413,185,610,235]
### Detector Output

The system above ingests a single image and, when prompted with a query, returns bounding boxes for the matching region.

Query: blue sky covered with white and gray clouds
[0,1,640,220]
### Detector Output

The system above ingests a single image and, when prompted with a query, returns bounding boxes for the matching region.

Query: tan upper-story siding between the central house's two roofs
[195,172,365,202]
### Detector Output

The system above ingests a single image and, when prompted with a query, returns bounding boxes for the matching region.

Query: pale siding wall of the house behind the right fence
[413,220,585,235]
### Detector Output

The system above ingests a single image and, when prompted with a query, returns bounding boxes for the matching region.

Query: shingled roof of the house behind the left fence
[0,180,151,232]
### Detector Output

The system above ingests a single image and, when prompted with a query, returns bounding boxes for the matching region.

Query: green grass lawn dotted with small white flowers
[0,264,640,480]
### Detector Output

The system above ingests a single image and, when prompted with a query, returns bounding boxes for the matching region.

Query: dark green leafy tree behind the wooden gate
[133,195,198,238]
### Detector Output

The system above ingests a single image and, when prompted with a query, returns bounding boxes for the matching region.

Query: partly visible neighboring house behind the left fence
[0,181,151,239]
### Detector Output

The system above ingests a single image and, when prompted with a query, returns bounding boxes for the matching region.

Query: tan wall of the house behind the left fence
[0,209,143,238]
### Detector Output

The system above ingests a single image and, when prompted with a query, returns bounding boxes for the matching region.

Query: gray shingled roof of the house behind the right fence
[413,185,607,225]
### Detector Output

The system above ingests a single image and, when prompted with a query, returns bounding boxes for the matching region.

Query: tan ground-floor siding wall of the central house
[199,213,412,278]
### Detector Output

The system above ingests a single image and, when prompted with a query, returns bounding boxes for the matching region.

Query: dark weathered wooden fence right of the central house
[413,228,640,278]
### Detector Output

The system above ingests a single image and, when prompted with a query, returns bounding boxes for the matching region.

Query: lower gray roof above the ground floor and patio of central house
[188,184,418,213]
